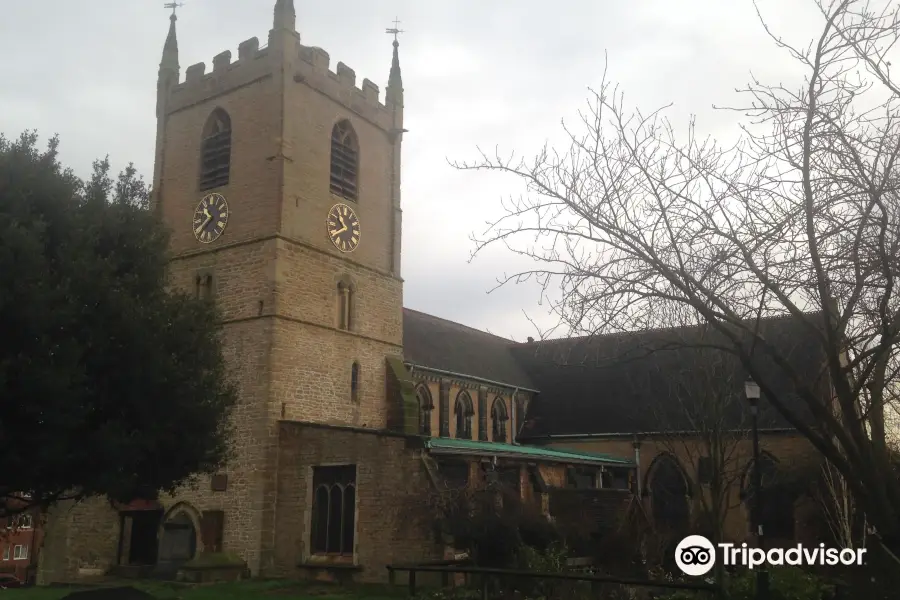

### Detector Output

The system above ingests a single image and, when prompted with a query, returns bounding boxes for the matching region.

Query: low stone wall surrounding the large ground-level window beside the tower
[270,422,443,581]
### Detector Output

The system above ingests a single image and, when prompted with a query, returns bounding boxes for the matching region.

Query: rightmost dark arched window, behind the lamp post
[741,452,795,540]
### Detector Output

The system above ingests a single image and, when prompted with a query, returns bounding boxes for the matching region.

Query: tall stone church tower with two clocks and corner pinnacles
[153,0,403,573]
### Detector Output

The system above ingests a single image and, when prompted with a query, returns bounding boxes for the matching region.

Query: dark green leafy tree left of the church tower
[0,133,236,511]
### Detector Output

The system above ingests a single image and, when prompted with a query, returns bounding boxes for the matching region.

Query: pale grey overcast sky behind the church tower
[0,0,820,340]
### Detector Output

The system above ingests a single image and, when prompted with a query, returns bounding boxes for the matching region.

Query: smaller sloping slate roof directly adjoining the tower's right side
[403,308,534,388]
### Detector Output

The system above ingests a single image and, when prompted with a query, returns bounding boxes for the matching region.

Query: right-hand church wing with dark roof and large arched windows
[512,314,830,544]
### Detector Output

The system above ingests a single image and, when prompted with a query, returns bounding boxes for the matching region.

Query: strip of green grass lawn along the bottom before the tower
[0,580,406,600]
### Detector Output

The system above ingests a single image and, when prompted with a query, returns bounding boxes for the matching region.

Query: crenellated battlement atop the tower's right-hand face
[294,45,393,130]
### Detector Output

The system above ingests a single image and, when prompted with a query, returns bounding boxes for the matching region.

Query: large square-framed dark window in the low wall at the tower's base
[312,465,356,556]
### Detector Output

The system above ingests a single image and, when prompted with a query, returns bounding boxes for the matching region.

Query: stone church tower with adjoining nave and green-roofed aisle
[33,0,824,582]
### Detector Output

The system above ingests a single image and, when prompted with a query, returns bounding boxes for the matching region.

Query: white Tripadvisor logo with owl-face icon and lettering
[675,535,866,577]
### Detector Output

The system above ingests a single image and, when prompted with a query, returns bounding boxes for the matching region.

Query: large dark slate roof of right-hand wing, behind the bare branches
[513,315,823,440]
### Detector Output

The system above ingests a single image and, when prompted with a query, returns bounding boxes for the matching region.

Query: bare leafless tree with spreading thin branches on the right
[457,0,900,536]
